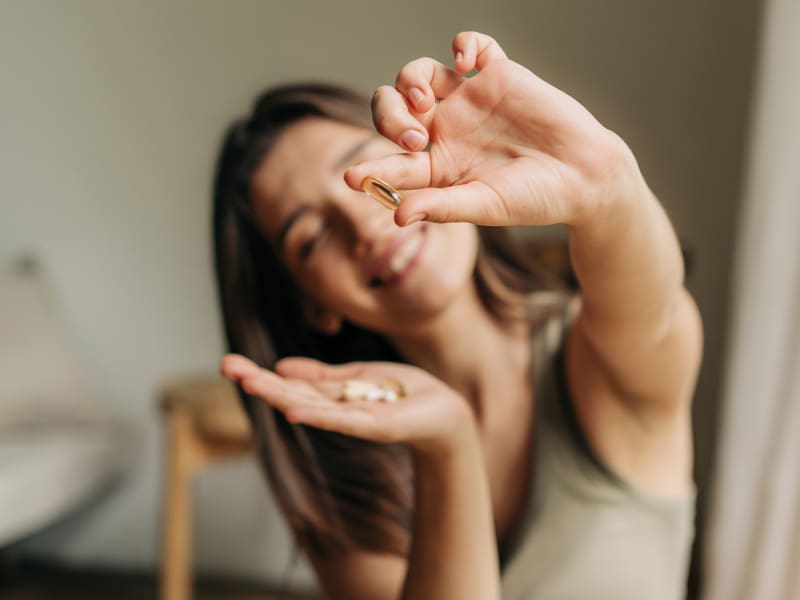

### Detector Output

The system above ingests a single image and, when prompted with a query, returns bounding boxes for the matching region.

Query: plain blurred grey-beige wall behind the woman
[0,0,757,575]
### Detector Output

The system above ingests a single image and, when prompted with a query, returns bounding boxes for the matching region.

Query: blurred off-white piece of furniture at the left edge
[0,259,129,547]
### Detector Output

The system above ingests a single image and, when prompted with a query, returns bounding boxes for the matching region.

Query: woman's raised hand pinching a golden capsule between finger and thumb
[345,32,645,231]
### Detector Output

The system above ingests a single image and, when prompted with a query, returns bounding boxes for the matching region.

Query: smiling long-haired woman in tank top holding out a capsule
[215,32,701,600]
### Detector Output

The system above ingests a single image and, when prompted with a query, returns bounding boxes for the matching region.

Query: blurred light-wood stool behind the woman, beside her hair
[160,376,251,600]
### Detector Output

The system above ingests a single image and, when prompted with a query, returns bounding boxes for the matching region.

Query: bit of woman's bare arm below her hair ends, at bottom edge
[308,550,407,600]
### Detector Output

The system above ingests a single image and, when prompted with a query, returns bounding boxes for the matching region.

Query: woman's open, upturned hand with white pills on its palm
[220,354,474,453]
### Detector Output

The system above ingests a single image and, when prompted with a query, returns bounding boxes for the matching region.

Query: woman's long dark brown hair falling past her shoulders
[213,83,551,555]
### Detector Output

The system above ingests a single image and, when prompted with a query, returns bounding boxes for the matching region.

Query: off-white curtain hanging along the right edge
[702,0,800,600]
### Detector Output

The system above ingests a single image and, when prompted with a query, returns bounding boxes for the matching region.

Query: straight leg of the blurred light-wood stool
[160,409,195,600]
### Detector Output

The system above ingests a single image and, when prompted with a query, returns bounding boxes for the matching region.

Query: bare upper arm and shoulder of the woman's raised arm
[566,290,702,496]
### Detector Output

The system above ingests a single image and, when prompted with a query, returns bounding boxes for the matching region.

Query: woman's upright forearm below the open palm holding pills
[402,427,500,600]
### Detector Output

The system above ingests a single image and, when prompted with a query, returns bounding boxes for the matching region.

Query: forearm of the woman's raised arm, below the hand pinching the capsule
[569,164,683,344]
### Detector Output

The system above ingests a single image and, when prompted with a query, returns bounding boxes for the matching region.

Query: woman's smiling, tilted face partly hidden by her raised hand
[251,117,478,335]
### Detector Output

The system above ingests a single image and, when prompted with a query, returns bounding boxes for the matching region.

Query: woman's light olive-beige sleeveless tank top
[502,302,694,600]
